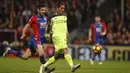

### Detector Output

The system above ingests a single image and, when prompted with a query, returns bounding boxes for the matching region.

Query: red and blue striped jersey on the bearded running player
[28,15,48,43]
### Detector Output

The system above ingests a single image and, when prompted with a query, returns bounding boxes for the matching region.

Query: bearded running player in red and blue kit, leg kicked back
[3,5,54,73]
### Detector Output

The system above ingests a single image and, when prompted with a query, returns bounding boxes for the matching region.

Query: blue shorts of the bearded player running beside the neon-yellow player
[28,36,44,52]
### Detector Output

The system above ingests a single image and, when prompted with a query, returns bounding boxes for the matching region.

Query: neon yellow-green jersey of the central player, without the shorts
[49,14,68,36]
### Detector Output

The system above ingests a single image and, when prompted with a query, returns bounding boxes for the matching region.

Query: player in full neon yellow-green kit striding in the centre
[43,2,81,72]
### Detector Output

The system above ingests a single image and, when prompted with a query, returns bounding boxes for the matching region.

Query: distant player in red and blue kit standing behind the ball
[88,16,106,65]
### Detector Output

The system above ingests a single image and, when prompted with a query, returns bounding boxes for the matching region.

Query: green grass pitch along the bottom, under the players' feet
[0,58,130,73]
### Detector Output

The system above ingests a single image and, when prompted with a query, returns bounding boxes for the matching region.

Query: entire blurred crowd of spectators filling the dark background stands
[0,0,130,45]
